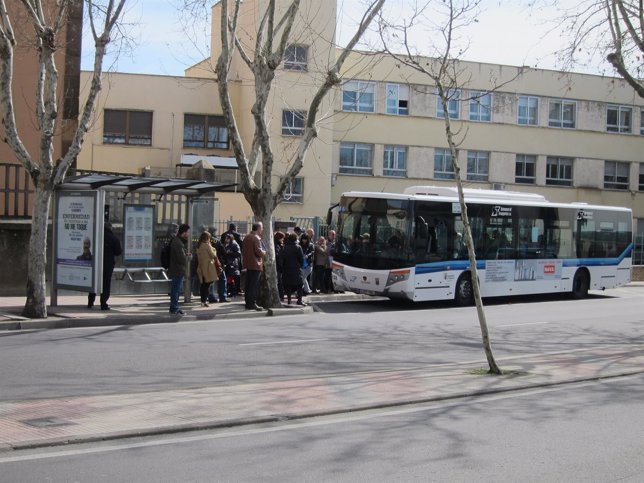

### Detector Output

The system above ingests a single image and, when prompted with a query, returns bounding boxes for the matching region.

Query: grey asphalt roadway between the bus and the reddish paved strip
[0,287,644,401]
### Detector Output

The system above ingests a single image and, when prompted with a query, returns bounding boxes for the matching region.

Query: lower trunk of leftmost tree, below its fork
[22,180,55,319]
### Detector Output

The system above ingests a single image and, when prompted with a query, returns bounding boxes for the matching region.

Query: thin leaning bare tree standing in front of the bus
[379,0,520,374]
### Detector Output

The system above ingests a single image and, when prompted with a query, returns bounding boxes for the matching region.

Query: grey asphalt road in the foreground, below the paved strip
[0,375,644,483]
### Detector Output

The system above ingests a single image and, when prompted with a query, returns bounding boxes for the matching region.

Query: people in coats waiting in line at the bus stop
[89,222,342,316]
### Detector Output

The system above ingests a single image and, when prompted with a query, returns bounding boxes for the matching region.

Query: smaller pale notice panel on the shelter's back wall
[123,205,154,262]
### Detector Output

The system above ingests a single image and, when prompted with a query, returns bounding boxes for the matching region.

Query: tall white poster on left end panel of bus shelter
[54,191,103,292]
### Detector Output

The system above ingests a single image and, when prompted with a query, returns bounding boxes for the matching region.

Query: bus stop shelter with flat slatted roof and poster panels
[51,173,235,306]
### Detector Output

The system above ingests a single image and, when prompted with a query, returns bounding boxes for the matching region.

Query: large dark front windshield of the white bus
[335,197,413,269]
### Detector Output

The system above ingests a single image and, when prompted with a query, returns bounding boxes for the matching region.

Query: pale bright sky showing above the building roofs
[82,0,600,75]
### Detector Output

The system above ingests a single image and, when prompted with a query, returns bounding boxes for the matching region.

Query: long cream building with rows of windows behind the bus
[78,0,644,240]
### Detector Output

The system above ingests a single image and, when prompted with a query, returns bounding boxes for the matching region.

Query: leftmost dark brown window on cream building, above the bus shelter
[103,109,152,146]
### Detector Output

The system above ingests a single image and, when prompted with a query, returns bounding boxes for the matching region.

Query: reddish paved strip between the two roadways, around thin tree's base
[0,346,644,450]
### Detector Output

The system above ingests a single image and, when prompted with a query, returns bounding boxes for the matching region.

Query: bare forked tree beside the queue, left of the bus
[210,0,385,307]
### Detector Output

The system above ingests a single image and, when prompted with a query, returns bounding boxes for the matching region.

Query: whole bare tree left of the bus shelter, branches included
[0,0,127,318]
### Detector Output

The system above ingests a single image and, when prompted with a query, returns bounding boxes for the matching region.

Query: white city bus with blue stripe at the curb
[332,186,633,305]
